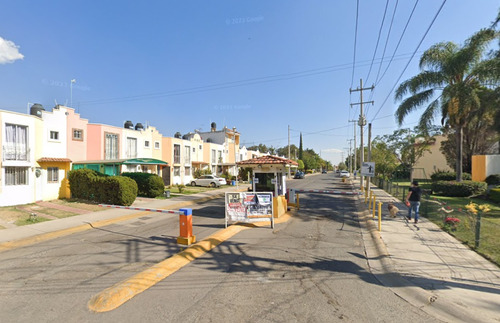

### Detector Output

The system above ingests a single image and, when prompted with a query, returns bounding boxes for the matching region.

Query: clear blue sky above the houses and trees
[0,0,500,164]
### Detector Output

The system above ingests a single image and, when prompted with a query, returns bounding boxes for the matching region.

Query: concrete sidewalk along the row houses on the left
[0,184,249,246]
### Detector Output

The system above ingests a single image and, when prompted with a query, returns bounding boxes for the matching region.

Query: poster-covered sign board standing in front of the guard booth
[225,192,274,228]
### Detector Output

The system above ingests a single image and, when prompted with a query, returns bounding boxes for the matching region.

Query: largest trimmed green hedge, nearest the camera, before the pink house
[68,169,137,206]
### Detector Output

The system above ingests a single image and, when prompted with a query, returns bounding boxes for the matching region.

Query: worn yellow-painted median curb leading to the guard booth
[88,213,290,312]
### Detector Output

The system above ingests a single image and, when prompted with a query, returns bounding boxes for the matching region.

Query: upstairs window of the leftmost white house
[2,124,29,161]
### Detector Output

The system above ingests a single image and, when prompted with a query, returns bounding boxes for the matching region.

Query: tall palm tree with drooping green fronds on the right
[395,29,500,181]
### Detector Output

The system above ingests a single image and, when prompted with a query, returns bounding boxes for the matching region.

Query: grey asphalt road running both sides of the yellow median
[0,174,436,322]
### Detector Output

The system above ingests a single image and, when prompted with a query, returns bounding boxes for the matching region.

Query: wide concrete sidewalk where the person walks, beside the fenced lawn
[353,180,500,322]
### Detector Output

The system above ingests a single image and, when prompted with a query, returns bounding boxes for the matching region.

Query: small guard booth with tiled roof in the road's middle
[237,155,299,218]
